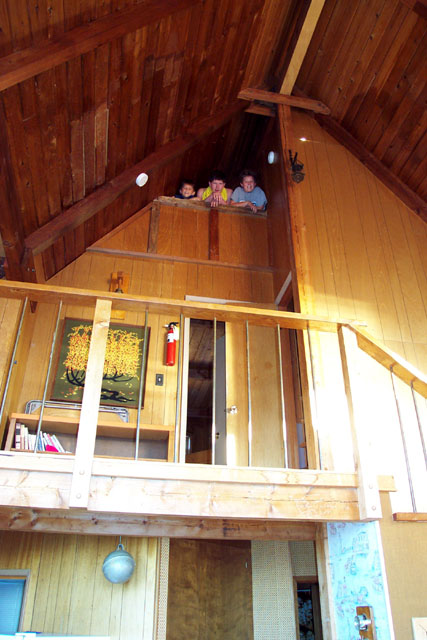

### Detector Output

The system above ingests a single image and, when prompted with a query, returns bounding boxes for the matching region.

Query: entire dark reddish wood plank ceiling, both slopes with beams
[0,0,427,279]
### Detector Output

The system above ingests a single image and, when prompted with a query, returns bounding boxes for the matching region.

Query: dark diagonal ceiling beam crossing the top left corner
[0,0,198,91]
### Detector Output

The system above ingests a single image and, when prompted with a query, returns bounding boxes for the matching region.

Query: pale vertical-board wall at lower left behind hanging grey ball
[0,531,159,640]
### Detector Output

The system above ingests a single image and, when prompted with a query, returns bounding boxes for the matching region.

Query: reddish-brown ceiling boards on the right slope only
[297,0,427,199]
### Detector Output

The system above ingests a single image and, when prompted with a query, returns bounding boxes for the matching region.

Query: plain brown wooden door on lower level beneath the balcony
[166,539,253,640]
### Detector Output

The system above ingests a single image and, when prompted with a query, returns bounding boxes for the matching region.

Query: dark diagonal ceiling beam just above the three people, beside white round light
[25,101,245,255]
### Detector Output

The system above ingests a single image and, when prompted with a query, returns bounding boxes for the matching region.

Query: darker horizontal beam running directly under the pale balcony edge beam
[0,507,317,540]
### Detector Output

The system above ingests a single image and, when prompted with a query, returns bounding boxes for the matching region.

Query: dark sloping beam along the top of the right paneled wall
[295,97,427,222]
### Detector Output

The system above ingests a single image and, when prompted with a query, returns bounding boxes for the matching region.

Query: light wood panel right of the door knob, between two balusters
[249,326,284,469]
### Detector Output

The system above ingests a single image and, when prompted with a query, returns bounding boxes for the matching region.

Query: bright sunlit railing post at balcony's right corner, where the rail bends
[338,326,381,520]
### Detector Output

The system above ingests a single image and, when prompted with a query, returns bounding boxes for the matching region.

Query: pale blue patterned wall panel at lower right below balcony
[328,522,394,640]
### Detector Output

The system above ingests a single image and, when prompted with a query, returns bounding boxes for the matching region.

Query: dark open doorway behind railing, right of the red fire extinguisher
[185,318,226,464]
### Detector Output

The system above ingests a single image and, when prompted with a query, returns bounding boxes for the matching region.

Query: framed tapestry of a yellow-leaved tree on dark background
[51,318,150,408]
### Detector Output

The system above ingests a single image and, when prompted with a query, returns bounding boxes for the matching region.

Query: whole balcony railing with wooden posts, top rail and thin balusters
[0,282,427,519]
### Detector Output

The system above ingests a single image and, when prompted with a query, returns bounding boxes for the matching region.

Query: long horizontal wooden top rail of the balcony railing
[0,280,364,333]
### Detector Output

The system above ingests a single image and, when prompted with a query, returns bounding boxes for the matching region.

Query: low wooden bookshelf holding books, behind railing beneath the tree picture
[4,413,175,462]
